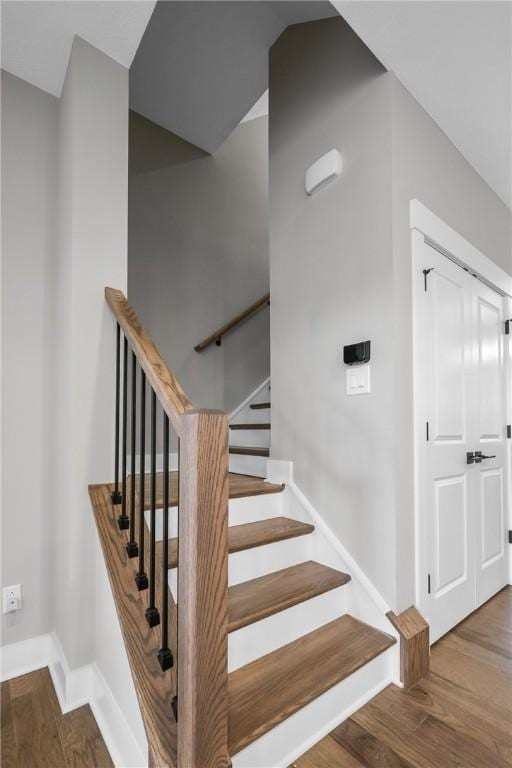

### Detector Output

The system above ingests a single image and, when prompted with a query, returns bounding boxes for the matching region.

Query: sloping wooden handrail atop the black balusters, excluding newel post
[105,288,194,435]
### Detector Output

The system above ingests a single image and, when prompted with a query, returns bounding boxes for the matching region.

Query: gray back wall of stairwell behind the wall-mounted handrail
[128,113,270,411]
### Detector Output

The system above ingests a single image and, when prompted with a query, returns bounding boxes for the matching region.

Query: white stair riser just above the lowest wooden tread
[228,587,345,672]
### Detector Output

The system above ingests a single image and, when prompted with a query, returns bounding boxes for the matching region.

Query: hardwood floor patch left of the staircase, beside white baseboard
[0,668,113,768]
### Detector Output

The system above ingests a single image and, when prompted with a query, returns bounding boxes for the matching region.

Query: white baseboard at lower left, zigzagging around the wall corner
[0,633,148,768]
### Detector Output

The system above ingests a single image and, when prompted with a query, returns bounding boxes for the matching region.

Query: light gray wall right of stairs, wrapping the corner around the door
[269,19,512,610]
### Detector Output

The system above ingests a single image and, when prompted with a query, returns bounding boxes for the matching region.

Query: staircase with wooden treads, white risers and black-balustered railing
[90,292,395,768]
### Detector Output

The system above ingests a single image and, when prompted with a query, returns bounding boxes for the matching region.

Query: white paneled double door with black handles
[415,243,508,640]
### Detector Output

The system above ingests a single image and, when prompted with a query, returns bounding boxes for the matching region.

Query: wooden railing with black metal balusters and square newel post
[105,288,231,768]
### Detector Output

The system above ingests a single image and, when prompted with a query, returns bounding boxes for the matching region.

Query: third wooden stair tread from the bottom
[162,517,315,568]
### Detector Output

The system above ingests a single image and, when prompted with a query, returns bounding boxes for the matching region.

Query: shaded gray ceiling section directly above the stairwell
[130,0,337,152]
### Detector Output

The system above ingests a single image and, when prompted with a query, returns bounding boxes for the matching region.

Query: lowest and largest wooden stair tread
[228,614,396,755]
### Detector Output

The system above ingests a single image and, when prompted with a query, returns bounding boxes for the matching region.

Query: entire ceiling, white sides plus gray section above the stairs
[1,0,512,206]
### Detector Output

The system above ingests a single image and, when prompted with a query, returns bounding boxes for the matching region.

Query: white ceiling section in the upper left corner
[1,0,155,96]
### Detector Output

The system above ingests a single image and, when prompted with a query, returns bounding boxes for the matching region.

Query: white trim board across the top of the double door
[409,200,512,296]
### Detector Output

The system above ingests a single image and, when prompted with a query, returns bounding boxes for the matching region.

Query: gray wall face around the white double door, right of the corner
[389,74,512,608]
